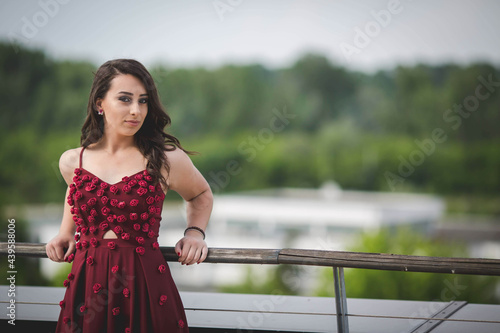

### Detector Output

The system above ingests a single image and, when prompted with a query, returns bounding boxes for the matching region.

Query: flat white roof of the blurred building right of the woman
[212,184,444,228]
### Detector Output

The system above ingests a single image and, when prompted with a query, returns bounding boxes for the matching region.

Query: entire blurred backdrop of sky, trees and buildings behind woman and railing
[0,0,500,303]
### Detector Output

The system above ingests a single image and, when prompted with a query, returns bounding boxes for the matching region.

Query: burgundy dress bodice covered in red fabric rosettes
[67,167,165,252]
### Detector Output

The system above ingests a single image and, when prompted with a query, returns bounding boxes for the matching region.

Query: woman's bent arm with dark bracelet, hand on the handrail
[167,149,213,265]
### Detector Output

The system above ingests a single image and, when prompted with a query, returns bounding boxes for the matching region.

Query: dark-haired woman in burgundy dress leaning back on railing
[46,59,213,333]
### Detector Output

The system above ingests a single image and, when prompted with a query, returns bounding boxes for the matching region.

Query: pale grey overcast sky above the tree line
[0,0,500,71]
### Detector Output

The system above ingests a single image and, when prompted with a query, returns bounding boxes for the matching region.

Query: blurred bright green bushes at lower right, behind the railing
[316,228,500,304]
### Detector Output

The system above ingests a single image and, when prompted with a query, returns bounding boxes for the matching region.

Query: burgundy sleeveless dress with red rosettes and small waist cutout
[56,148,188,333]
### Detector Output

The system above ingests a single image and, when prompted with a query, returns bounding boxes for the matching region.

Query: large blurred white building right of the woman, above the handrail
[210,183,445,250]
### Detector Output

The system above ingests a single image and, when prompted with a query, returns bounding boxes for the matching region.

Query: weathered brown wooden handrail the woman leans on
[0,242,500,276]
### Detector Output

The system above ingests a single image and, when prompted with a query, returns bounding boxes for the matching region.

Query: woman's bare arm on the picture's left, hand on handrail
[45,149,78,262]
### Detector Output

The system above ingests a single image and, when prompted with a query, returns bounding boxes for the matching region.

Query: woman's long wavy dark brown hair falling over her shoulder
[80,59,192,188]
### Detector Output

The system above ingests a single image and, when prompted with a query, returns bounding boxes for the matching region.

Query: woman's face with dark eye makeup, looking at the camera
[96,74,148,136]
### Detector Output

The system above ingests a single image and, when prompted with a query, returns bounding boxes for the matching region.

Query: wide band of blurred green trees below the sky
[0,43,500,210]
